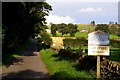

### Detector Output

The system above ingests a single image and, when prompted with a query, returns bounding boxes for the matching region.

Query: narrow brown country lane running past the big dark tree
[2,40,49,80]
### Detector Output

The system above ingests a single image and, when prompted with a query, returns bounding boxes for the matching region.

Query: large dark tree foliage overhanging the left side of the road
[2,2,52,53]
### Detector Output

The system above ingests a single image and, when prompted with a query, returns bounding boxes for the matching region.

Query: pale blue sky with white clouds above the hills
[46,0,119,24]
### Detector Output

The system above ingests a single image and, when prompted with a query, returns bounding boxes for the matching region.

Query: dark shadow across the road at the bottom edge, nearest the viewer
[2,70,49,80]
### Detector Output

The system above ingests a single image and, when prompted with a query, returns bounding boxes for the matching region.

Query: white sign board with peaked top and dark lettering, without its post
[88,30,110,56]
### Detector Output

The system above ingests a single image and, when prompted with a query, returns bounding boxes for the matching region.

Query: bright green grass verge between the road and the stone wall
[40,49,95,80]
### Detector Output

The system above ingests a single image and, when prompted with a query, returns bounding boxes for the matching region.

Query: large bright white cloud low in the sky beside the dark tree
[46,14,75,24]
